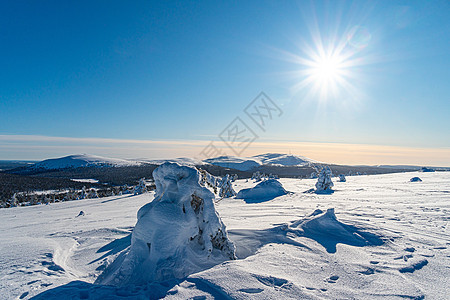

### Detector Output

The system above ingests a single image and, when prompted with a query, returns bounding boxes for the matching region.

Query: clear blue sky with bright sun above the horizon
[0,1,450,165]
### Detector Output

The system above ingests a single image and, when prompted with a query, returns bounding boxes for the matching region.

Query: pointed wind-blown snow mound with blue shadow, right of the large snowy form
[290,208,383,253]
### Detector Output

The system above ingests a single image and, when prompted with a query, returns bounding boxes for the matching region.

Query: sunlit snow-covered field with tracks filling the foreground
[0,172,450,299]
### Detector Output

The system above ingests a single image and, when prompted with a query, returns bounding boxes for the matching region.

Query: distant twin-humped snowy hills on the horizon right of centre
[204,153,317,171]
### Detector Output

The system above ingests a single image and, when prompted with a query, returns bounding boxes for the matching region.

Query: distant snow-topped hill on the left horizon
[30,154,142,170]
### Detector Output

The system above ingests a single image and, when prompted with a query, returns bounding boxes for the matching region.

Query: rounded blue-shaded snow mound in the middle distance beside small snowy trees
[236,179,287,203]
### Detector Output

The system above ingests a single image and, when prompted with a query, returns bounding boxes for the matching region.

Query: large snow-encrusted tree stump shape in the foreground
[97,163,236,286]
